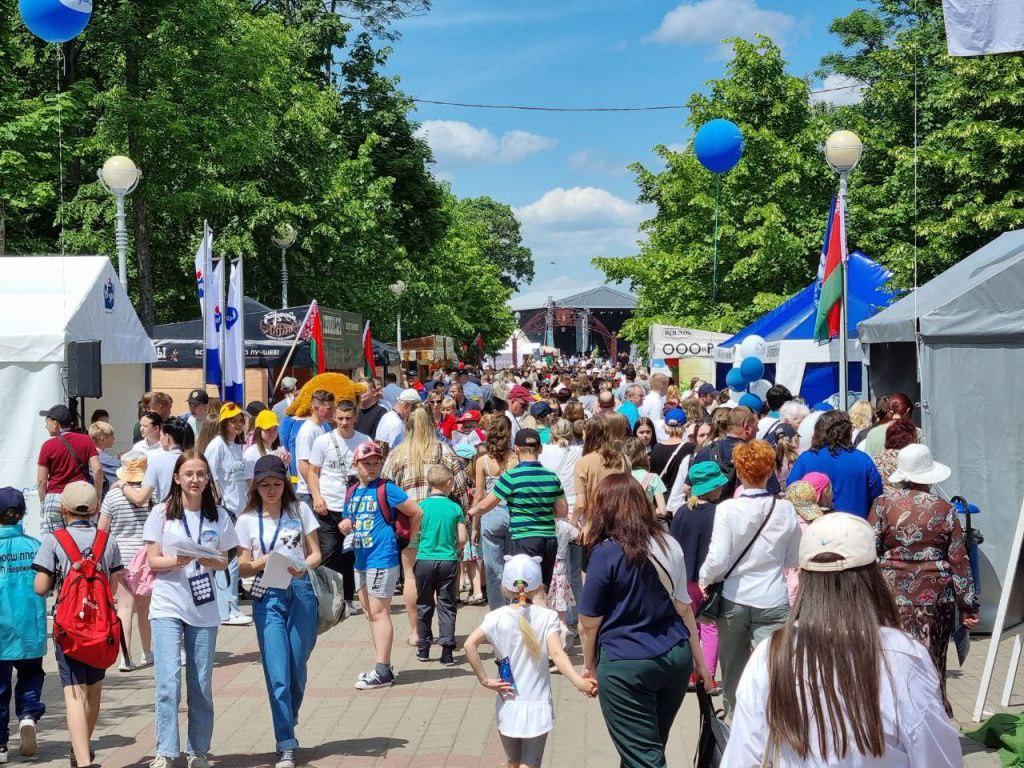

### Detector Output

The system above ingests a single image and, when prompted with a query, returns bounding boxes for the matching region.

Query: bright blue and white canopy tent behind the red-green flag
[715,251,896,404]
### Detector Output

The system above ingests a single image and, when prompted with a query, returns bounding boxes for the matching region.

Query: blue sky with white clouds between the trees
[389,0,856,301]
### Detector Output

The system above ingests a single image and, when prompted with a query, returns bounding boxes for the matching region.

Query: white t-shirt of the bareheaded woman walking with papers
[142,504,239,627]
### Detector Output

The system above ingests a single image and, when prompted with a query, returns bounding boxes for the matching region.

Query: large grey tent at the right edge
[858,229,1024,628]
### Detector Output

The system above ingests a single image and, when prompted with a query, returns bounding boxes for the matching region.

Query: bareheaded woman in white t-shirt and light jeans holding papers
[142,451,238,768]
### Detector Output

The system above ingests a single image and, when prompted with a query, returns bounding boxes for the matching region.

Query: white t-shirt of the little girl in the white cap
[480,605,559,738]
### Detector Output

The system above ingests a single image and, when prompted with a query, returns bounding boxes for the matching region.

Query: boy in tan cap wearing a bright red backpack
[32,481,123,768]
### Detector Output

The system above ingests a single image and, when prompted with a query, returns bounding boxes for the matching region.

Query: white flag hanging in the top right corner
[942,0,1024,56]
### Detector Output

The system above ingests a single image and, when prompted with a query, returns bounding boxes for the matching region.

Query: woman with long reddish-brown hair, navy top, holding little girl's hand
[579,473,714,768]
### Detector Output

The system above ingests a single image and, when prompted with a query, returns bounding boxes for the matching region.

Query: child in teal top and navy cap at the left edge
[0,487,46,763]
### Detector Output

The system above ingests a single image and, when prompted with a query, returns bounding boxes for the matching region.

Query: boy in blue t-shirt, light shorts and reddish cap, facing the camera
[338,440,423,690]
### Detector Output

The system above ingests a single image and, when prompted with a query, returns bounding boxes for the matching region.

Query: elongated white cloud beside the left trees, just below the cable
[416,120,558,171]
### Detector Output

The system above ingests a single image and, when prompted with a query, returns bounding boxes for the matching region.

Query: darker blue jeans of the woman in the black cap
[253,575,318,752]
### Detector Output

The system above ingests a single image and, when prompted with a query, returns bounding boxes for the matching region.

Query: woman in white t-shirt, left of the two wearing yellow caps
[203,402,252,626]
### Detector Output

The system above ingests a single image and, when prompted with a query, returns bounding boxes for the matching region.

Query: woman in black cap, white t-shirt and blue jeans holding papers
[234,456,321,768]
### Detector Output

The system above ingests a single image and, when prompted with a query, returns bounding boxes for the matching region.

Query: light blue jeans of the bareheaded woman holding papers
[150,618,217,760]
